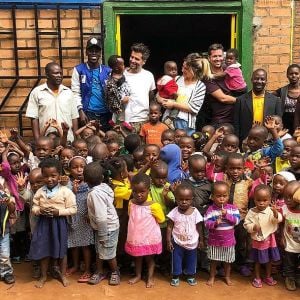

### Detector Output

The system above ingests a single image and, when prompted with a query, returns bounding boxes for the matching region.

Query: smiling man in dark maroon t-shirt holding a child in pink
[200,44,236,127]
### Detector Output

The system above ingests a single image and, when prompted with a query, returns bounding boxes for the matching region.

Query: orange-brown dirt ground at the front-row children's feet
[0,263,300,300]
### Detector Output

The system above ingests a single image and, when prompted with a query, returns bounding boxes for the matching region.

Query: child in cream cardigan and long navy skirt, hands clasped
[29,158,77,288]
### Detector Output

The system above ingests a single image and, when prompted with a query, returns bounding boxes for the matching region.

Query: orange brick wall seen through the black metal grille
[0,8,101,134]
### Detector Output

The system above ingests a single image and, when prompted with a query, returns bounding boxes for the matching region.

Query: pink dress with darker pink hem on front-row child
[125,203,162,256]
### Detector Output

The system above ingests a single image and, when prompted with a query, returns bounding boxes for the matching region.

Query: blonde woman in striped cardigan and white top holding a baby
[157,53,211,135]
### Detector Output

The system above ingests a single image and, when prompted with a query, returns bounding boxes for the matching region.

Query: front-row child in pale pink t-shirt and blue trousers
[167,184,203,286]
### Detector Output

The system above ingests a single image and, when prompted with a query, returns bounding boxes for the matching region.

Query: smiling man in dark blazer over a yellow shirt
[234,69,282,142]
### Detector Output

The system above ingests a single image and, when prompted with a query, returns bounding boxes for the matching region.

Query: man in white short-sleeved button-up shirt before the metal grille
[26,62,78,141]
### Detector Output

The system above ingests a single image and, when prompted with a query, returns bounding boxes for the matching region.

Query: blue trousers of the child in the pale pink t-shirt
[172,241,197,276]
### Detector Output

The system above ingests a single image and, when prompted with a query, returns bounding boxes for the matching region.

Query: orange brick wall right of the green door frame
[253,0,292,90]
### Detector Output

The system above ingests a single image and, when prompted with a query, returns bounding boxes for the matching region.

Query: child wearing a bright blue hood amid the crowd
[160,144,187,184]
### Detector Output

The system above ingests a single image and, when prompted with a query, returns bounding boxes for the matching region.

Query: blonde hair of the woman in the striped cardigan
[184,53,213,80]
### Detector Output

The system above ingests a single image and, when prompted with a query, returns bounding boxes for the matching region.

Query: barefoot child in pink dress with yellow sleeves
[125,173,165,288]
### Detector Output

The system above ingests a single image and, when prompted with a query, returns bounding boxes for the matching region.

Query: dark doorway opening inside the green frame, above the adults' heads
[120,14,231,78]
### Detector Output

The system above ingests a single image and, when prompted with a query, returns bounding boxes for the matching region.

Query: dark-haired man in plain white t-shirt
[124,43,155,133]
